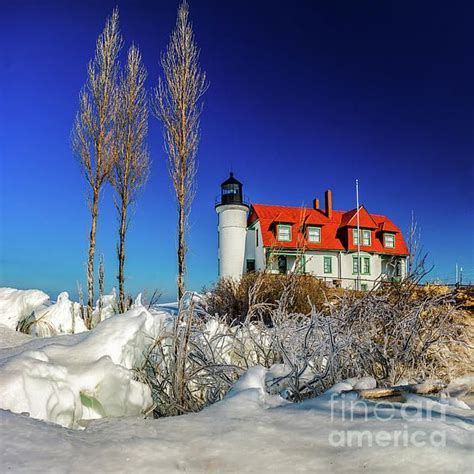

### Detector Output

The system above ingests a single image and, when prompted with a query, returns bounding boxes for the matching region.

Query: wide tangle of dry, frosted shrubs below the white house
[143,274,474,416]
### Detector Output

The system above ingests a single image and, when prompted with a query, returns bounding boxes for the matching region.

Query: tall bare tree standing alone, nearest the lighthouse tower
[153,1,208,299]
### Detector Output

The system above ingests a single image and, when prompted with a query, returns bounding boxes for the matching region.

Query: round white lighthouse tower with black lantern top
[216,173,249,280]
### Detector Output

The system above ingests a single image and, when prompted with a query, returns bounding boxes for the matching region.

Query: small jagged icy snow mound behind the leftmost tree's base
[28,291,87,337]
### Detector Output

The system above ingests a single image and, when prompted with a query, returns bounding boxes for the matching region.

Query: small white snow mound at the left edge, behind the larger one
[0,288,49,329]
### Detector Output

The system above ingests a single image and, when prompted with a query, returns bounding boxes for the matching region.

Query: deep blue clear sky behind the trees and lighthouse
[0,0,474,300]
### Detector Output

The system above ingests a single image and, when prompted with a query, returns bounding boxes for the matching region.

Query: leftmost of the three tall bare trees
[72,9,122,327]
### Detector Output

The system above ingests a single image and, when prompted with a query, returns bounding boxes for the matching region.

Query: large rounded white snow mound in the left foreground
[0,307,165,428]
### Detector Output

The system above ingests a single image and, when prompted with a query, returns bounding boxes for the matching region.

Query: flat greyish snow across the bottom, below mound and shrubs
[0,367,472,473]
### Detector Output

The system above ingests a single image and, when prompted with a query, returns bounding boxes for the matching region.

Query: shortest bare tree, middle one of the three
[110,46,150,312]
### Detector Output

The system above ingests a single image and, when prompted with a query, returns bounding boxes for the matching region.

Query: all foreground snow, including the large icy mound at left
[0,286,474,473]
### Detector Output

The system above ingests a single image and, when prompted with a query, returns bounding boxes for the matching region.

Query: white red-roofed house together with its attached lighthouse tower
[216,173,409,290]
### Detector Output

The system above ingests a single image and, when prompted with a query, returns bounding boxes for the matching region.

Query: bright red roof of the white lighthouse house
[248,204,409,255]
